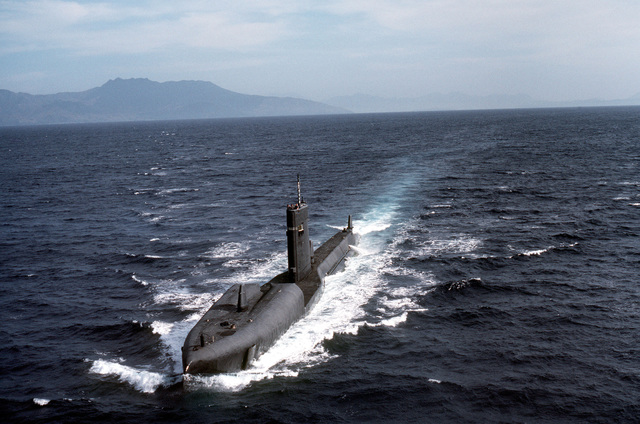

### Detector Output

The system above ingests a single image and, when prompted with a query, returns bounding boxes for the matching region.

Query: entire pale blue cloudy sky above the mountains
[0,0,640,101]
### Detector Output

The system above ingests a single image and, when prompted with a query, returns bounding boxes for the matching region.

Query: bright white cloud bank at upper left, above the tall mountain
[0,0,286,55]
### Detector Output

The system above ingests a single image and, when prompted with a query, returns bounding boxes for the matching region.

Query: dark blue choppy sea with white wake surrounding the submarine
[0,107,640,424]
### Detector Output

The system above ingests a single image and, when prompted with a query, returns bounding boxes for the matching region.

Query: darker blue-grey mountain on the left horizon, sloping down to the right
[0,78,348,126]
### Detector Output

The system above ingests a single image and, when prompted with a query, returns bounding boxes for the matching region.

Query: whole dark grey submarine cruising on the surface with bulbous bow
[182,176,358,374]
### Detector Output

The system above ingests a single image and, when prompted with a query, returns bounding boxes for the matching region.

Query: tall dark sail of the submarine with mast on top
[287,175,313,283]
